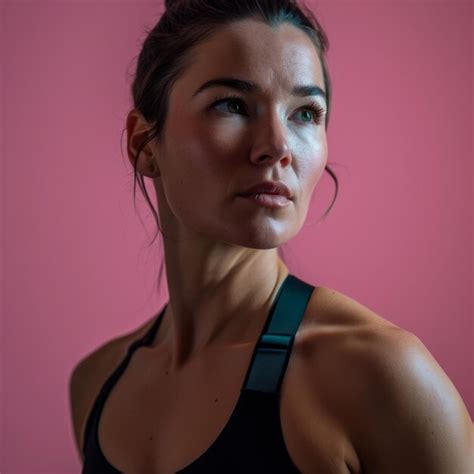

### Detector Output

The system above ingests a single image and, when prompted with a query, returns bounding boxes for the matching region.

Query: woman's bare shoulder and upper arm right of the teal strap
[299,288,474,473]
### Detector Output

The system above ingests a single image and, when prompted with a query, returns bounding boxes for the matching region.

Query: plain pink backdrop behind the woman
[0,0,474,474]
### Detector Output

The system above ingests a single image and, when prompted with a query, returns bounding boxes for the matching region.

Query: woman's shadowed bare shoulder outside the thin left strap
[69,316,155,461]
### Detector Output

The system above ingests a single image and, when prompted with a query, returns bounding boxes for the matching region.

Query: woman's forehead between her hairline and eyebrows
[175,19,325,100]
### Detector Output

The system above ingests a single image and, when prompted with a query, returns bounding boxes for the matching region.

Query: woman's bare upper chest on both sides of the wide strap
[98,335,358,474]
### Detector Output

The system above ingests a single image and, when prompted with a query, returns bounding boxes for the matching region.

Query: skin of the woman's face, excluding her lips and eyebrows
[154,20,327,249]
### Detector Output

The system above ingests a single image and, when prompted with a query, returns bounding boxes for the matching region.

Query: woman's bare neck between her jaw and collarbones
[154,249,288,371]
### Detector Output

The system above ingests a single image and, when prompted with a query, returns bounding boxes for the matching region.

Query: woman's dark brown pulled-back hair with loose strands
[120,0,339,294]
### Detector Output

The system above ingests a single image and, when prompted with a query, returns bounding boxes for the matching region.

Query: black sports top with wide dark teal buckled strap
[82,274,315,474]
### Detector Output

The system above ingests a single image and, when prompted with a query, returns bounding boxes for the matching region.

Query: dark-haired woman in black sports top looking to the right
[71,0,473,474]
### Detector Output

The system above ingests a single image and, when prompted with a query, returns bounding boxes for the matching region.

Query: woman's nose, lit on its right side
[250,113,291,165]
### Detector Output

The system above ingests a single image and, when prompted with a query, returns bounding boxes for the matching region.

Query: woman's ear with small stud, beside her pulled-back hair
[127,109,160,178]
